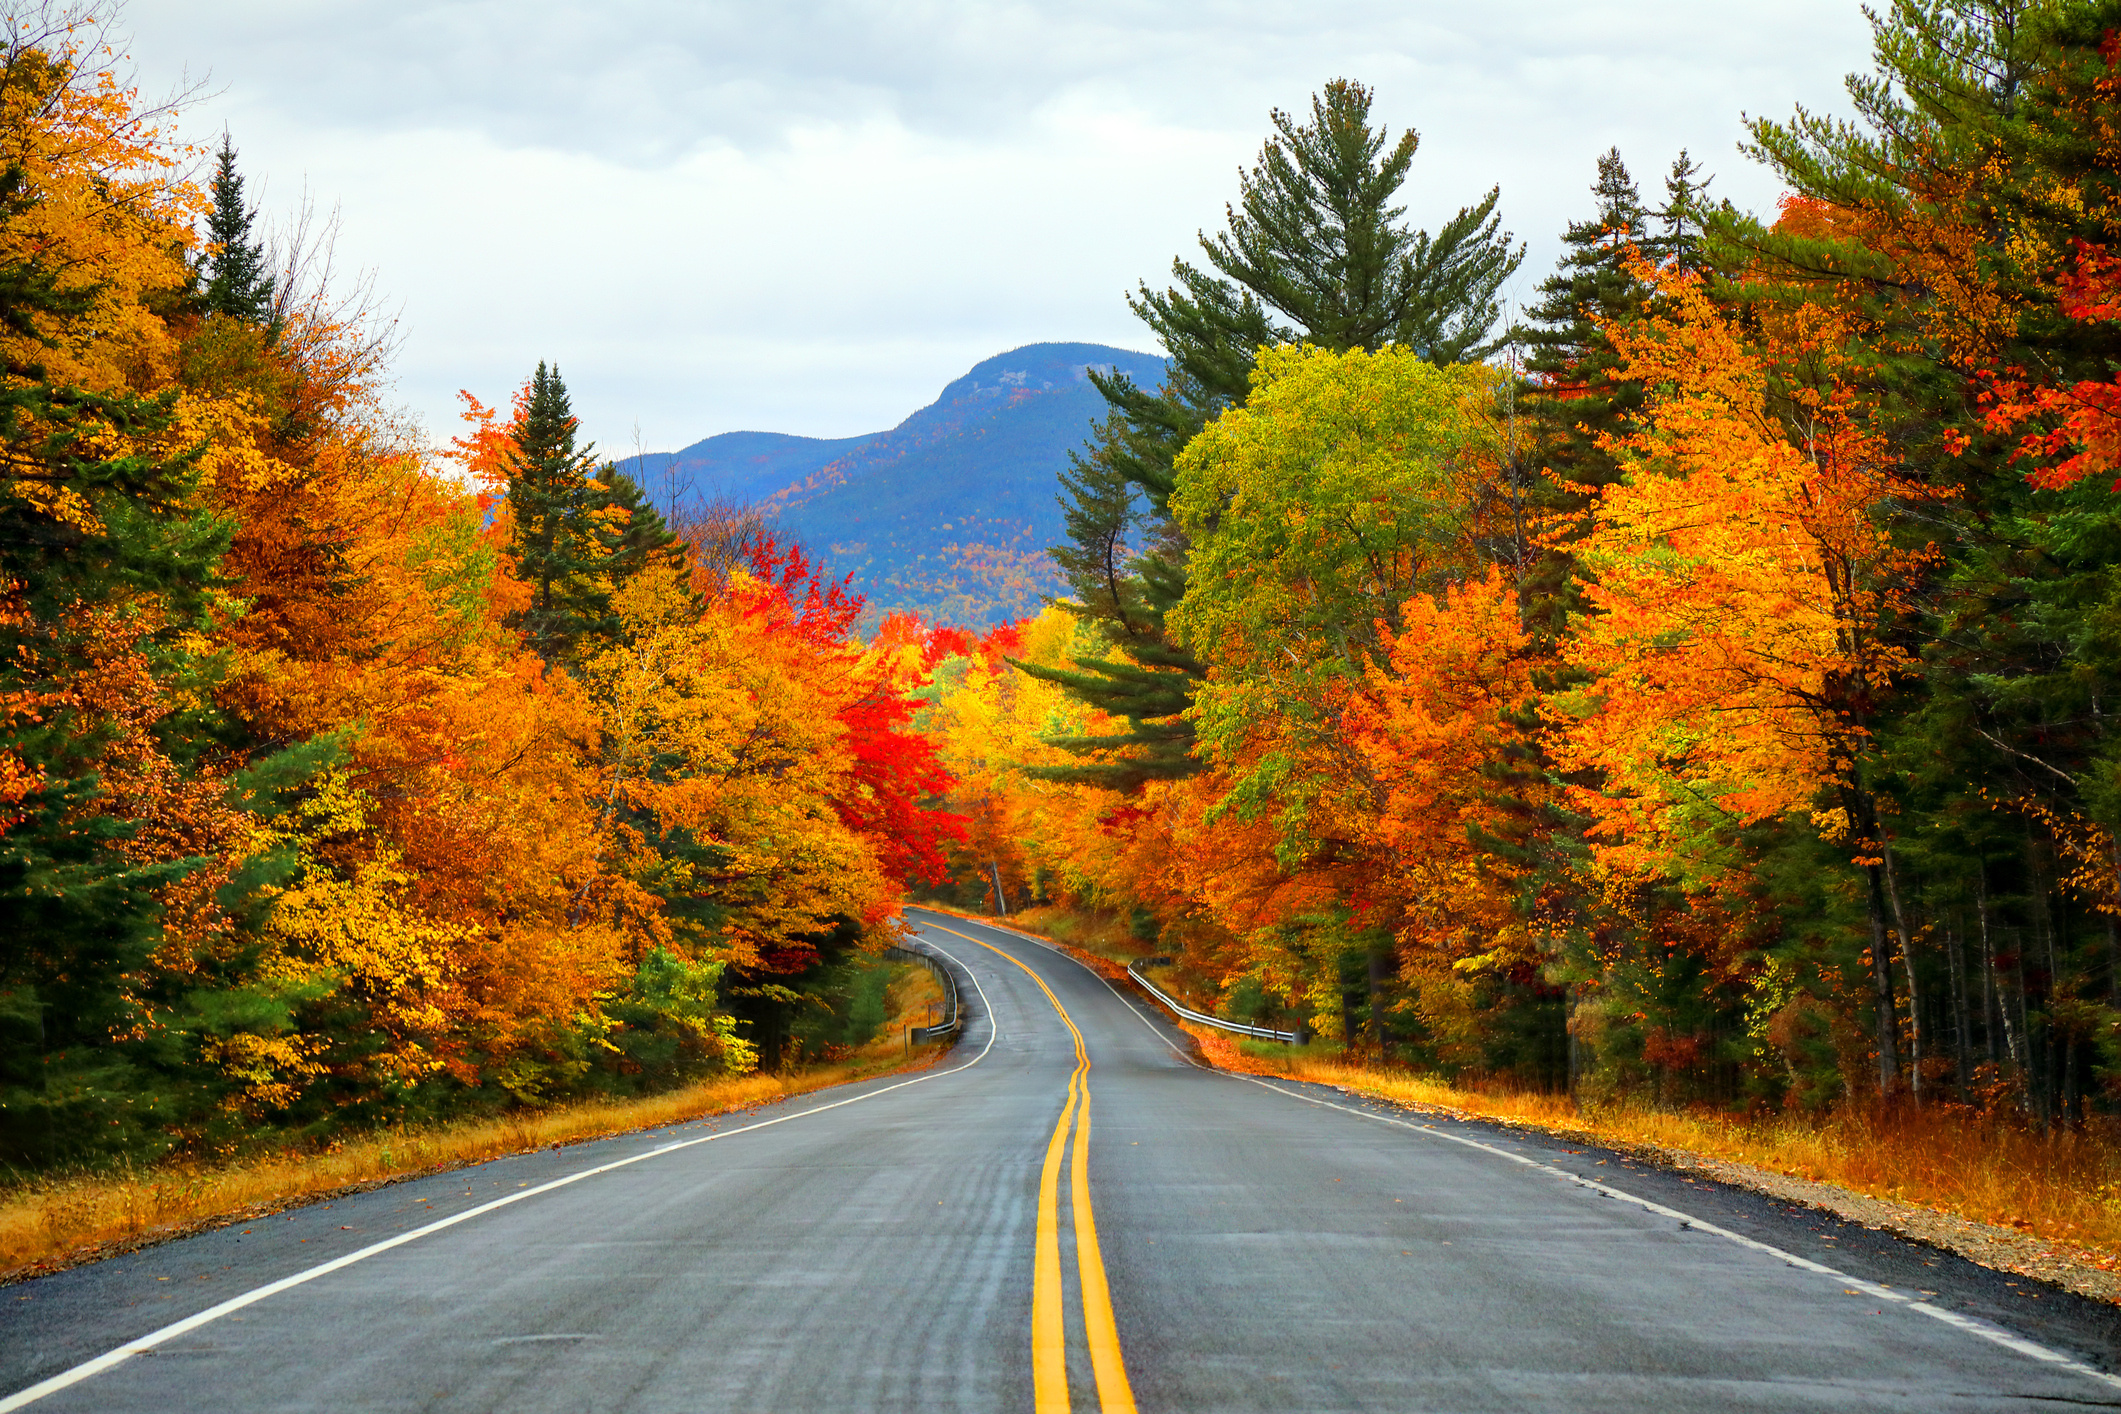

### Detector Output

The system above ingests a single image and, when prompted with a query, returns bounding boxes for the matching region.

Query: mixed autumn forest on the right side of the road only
[944,0,2121,1128]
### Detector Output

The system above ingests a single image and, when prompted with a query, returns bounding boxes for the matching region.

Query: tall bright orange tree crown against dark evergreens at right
[1548,267,1909,873]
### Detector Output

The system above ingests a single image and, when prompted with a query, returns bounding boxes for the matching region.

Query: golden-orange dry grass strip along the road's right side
[1186,1026,2121,1270]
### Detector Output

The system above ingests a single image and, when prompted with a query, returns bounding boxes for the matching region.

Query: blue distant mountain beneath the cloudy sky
[649,343,1164,625]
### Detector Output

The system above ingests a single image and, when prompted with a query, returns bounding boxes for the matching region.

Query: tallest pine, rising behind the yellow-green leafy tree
[1024,78,1523,789]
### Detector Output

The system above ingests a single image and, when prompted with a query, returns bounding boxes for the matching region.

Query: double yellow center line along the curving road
[921,922,1135,1414]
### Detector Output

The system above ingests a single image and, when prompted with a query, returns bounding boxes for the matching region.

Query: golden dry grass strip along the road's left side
[0,967,942,1283]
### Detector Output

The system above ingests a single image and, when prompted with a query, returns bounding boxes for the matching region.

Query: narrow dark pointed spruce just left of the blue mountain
[509,363,615,661]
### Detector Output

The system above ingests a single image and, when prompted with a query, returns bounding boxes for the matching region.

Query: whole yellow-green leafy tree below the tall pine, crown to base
[1171,346,1497,1051]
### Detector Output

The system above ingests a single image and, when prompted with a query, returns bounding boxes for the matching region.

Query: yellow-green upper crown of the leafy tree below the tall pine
[1171,346,1497,831]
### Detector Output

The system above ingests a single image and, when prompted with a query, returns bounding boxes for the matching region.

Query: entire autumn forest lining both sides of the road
[0,0,2121,1170]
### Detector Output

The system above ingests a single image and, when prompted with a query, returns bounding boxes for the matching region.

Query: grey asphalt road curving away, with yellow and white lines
[0,916,2121,1414]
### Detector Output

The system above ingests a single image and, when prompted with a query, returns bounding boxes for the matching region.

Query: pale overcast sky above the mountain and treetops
[123,0,1866,452]
